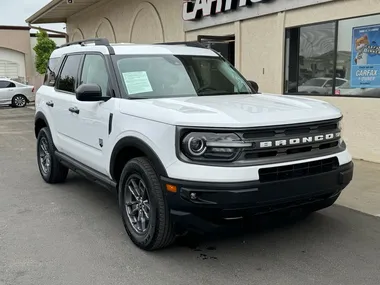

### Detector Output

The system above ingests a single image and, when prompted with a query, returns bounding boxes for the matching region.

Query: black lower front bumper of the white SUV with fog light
[161,162,354,231]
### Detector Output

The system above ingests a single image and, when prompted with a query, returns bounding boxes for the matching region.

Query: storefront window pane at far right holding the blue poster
[335,15,380,97]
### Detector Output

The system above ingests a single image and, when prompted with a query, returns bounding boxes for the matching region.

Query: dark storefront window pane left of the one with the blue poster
[285,22,336,95]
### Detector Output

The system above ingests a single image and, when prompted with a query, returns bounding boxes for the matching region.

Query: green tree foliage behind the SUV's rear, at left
[33,31,57,74]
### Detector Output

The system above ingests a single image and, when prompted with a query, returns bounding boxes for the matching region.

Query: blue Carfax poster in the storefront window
[350,25,380,88]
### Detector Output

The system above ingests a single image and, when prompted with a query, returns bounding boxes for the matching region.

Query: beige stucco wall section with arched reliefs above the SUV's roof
[67,0,184,43]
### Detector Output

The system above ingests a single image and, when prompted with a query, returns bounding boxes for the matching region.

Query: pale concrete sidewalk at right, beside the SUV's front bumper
[336,160,380,217]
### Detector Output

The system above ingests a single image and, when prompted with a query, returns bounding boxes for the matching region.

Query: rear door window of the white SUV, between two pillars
[57,55,82,93]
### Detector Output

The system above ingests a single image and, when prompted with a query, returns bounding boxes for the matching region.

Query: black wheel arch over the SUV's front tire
[110,136,167,182]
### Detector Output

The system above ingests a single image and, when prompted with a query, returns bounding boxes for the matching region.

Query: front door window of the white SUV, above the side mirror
[80,55,109,96]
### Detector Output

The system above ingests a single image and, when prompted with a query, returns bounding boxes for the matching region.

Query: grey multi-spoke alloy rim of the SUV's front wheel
[124,174,151,234]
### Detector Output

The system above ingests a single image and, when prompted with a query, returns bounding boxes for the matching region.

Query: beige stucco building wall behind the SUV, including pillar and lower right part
[67,0,380,163]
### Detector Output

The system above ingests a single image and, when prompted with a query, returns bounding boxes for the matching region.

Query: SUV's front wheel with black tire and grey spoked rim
[119,157,174,251]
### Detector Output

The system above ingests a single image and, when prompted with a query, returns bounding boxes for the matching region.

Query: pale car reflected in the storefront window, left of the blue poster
[298,77,347,95]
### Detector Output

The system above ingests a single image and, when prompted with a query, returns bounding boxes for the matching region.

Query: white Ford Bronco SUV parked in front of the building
[35,39,353,250]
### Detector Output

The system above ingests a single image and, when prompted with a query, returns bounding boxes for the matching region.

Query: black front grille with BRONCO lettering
[239,119,340,161]
